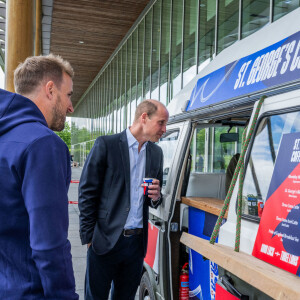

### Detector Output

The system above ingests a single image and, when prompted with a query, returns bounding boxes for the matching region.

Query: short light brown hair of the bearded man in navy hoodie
[14,54,74,95]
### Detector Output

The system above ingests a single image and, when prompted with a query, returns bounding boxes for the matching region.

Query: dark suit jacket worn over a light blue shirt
[78,130,163,255]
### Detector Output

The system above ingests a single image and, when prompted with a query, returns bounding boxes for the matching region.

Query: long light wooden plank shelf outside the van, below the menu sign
[180,232,300,300]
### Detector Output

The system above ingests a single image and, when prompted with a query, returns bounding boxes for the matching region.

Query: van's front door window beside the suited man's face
[157,130,179,187]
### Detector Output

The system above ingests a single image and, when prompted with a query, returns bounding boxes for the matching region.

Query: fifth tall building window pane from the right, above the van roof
[183,0,198,86]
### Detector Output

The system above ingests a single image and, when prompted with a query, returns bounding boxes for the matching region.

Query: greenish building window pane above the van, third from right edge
[218,0,239,53]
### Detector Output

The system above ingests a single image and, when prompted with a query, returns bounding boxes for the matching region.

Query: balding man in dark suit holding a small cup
[79,100,169,300]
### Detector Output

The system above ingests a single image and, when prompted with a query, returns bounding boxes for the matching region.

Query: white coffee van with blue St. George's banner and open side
[139,9,300,300]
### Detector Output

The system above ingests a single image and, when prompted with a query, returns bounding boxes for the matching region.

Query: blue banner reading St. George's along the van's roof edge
[186,31,300,111]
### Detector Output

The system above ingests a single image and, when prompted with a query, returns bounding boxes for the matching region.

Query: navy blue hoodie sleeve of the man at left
[22,134,78,299]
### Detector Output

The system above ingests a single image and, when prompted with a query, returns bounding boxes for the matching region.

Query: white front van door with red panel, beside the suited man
[142,121,191,299]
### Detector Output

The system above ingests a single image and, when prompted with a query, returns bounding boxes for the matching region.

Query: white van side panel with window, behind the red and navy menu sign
[219,91,300,299]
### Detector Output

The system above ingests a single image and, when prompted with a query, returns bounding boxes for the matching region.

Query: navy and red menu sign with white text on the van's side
[252,132,300,276]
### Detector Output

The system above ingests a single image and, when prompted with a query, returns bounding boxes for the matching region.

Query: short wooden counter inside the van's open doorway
[181,197,228,219]
